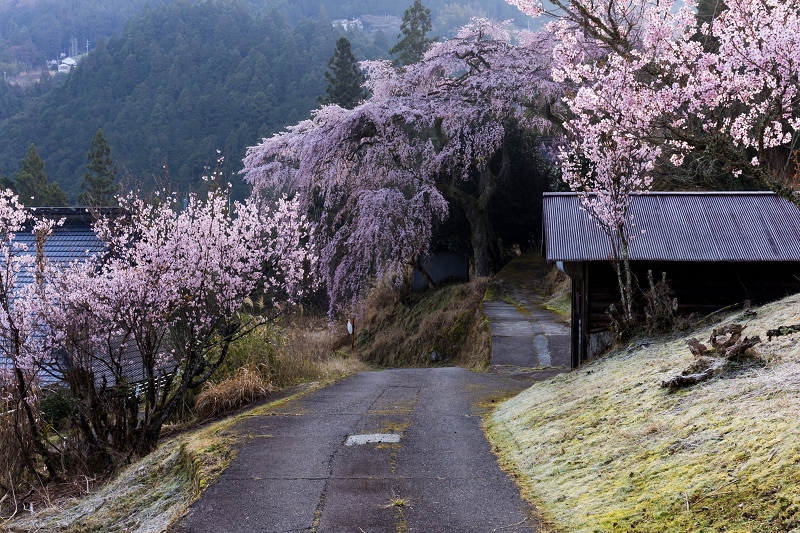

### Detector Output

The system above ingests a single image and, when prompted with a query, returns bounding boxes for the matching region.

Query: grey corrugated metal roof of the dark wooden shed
[543,192,800,261]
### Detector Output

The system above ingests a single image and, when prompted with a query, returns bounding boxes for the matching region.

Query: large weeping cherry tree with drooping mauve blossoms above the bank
[243,20,558,312]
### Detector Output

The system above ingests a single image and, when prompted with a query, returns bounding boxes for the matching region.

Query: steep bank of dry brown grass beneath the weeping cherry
[356,278,489,369]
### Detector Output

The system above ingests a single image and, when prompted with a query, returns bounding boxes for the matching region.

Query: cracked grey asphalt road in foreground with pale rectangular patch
[174,368,539,533]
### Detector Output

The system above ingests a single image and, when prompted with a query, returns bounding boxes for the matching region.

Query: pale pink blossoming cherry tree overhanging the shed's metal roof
[509,0,800,320]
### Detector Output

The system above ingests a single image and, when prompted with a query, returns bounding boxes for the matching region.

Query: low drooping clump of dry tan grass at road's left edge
[194,366,275,418]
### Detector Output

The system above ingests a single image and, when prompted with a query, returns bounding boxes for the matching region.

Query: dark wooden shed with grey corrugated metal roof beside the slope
[543,192,800,367]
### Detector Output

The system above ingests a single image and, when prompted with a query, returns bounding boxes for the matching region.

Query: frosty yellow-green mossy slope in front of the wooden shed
[487,295,800,532]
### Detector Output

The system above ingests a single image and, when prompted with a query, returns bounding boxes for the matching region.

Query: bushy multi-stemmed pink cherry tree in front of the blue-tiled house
[49,181,314,462]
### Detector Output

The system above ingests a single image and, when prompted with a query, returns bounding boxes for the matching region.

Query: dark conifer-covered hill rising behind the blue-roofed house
[0,0,386,201]
